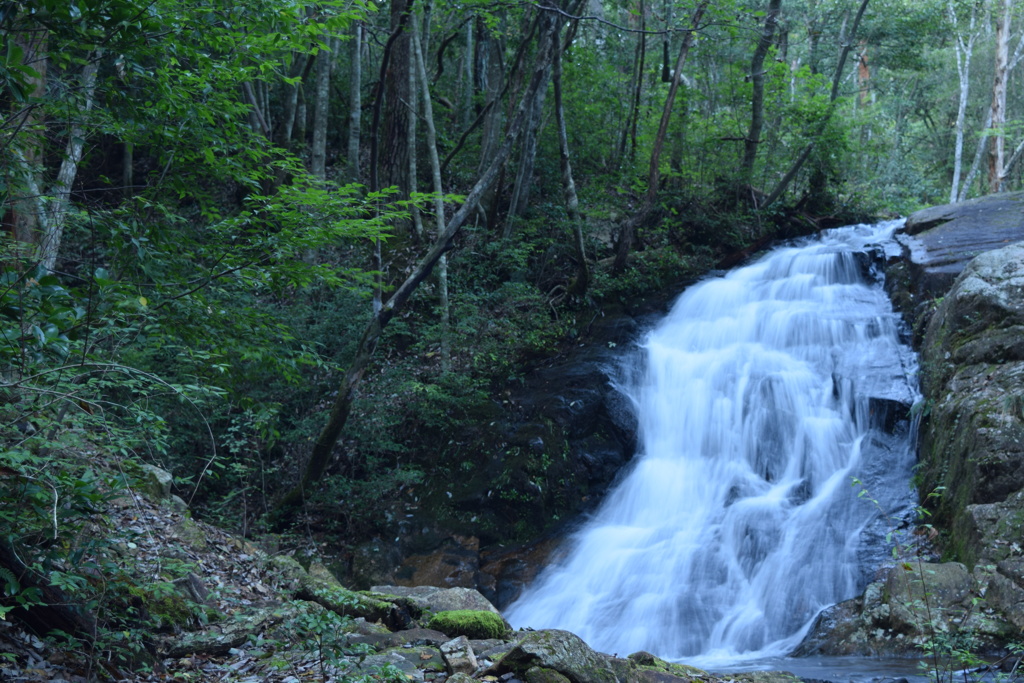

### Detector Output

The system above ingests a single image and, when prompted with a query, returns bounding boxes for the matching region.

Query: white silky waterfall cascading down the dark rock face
[506,221,916,666]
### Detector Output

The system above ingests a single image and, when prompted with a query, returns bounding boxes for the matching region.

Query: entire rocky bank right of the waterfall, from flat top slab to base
[798,194,1024,654]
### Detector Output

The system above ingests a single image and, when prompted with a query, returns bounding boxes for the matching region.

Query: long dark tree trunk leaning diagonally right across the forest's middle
[278,9,555,510]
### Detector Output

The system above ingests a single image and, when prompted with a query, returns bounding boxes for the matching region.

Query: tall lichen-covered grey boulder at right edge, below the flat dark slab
[921,244,1024,566]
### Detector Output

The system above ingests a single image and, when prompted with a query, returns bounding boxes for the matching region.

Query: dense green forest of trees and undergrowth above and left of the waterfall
[0,0,1024,663]
